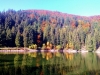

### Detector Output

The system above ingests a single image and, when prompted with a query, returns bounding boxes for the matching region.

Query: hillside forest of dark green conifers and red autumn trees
[0,10,100,50]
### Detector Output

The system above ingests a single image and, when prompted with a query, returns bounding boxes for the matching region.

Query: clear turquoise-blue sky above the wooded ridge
[0,0,100,16]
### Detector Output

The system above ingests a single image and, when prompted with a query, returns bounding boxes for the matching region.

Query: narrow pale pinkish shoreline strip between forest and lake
[0,48,100,53]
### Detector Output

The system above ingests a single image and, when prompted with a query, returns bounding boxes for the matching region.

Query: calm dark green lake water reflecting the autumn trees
[0,52,100,75]
